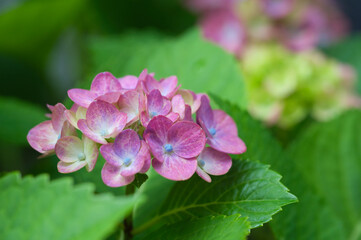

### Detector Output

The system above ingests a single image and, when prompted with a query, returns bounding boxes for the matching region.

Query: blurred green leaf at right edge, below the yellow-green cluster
[288,110,361,239]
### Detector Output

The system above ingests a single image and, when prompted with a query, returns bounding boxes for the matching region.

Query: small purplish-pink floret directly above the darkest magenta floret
[140,89,179,127]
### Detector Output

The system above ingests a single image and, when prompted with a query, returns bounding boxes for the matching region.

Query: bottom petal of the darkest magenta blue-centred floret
[152,153,197,181]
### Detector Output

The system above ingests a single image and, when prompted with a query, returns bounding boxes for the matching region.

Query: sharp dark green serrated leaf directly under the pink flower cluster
[134,160,296,232]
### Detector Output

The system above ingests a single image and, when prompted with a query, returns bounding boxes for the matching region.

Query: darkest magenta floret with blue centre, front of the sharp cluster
[143,116,206,181]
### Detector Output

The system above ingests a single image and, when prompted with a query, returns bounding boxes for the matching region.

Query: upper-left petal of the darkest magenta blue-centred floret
[143,116,173,161]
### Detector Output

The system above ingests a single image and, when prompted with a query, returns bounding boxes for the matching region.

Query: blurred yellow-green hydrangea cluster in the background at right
[241,45,361,128]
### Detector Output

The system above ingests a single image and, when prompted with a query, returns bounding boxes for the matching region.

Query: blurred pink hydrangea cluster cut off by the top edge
[184,0,348,56]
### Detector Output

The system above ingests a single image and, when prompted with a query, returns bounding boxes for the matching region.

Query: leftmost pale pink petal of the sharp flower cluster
[26,120,60,153]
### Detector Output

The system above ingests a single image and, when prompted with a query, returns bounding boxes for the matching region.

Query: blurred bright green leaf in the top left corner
[0,0,86,62]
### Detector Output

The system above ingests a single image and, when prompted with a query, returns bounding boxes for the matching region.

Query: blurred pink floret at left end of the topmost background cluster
[200,10,245,56]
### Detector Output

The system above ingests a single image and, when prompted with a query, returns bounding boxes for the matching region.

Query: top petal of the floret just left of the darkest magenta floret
[113,129,141,159]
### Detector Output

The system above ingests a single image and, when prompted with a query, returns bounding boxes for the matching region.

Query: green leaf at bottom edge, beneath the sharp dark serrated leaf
[144,215,250,240]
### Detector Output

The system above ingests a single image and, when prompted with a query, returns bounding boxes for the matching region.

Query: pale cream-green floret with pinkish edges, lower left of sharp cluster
[55,136,98,173]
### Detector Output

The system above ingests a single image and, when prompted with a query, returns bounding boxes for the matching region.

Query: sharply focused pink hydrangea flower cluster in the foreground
[27,70,246,187]
